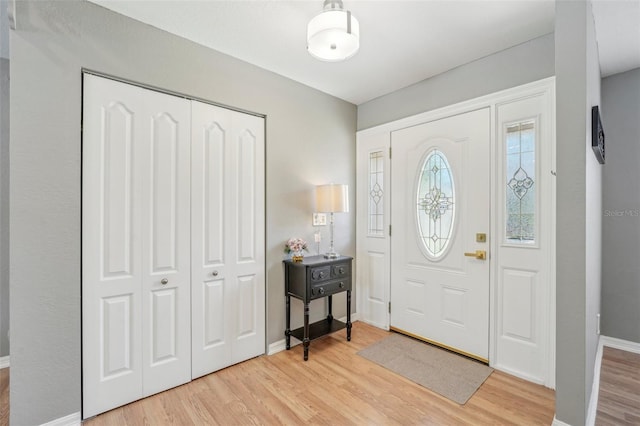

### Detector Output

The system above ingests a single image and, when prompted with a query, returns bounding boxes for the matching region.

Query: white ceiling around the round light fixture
[90,0,640,105]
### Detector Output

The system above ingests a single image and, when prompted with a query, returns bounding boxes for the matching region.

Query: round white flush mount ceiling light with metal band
[307,0,360,62]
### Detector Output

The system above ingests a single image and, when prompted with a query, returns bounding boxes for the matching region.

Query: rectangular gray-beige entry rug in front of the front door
[358,333,493,405]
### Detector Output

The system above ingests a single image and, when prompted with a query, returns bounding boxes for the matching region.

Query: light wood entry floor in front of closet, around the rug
[84,322,554,426]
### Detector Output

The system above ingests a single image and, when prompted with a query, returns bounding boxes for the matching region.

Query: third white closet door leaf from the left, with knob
[191,102,235,378]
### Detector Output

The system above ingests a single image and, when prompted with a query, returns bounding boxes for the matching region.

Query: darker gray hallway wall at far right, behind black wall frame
[601,68,640,343]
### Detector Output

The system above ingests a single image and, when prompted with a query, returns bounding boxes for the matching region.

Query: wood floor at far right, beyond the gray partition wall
[596,346,640,426]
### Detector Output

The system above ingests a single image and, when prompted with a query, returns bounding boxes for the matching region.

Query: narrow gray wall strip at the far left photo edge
[0,58,10,357]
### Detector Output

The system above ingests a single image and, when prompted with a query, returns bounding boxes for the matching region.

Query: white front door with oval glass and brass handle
[390,108,491,360]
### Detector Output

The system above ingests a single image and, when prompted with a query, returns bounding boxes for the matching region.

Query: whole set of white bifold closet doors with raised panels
[82,74,264,418]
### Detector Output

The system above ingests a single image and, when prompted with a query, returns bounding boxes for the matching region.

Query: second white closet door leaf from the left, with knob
[144,89,191,396]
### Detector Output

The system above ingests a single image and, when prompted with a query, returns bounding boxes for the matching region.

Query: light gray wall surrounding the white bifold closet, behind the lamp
[11,1,356,425]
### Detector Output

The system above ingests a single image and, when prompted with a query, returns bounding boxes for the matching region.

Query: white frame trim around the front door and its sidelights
[356,76,556,388]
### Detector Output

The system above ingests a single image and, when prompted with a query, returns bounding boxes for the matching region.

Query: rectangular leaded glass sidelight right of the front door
[505,121,537,244]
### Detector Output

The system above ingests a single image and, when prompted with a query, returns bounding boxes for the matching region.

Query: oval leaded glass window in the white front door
[416,149,455,258]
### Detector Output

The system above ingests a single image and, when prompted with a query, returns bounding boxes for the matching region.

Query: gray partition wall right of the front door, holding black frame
[555,1,602,425]
